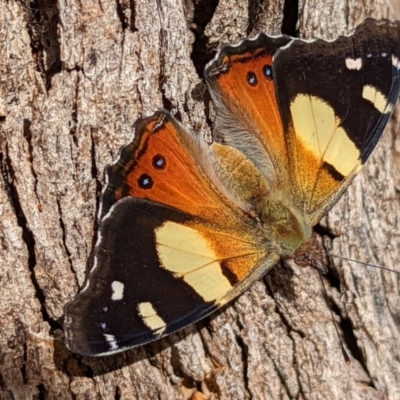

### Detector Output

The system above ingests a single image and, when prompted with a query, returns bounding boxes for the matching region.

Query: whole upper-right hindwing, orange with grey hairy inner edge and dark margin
[204,34,292,186]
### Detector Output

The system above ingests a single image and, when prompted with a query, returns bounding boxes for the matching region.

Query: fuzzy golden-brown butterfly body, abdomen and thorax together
[212,143,312,256]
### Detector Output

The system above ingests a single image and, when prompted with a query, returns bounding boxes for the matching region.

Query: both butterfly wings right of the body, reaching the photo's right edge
[205,19,400,224]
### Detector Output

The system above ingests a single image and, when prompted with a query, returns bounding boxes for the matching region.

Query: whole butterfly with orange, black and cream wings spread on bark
[64,19,400,356]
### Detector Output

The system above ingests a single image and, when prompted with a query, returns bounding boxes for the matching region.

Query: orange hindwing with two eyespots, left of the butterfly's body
[109,113,238,219]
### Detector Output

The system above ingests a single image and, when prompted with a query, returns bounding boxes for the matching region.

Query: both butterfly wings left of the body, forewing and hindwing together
[64,111,279,356]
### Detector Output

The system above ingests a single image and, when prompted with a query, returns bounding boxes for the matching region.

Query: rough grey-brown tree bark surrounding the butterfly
[0,0,400,400]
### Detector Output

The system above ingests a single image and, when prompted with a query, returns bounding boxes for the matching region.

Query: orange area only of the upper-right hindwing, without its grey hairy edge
[210,49,287,180]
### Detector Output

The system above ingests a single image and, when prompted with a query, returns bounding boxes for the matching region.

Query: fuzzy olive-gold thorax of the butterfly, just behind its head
[256,196,312,257]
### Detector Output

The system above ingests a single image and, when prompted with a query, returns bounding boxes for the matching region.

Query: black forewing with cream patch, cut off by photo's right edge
[274,19,400,224]
